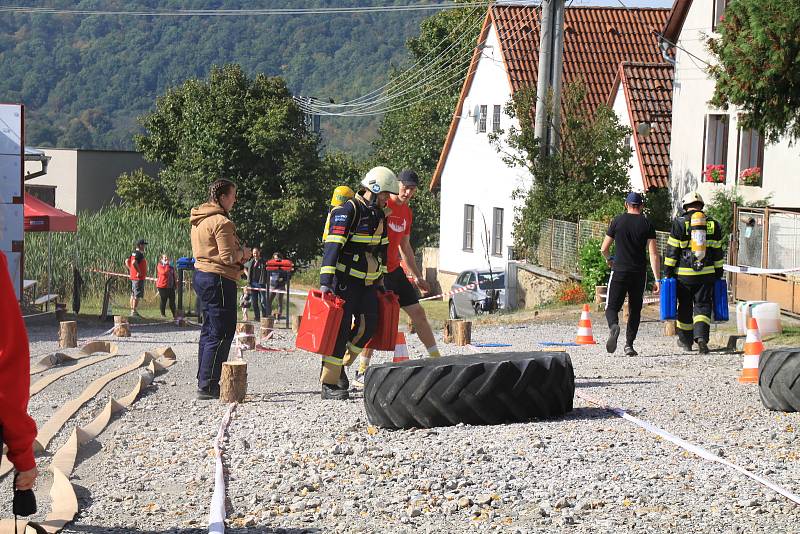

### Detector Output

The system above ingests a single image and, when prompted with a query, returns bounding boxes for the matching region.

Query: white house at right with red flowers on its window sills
[663,0,800,207]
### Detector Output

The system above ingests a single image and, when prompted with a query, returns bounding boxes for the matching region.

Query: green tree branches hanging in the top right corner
[708,0,800,142]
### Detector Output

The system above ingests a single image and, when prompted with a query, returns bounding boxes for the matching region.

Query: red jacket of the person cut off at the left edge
[0,252,36,471]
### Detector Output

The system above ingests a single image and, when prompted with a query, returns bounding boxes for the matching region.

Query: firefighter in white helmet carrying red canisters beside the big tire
[319,167,399,400]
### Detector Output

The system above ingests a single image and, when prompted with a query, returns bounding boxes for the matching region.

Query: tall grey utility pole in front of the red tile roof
[533,0,565,156]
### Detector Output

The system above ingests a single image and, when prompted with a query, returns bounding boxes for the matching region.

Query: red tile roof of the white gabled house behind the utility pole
[431,5,669,189]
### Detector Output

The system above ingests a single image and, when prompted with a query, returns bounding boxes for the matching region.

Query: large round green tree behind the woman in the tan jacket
[136,65,330,262]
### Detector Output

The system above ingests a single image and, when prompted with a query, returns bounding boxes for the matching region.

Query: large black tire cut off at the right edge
[758,349,800,412]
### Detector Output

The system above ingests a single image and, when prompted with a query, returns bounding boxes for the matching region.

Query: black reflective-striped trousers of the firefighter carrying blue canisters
[675,275,714,345]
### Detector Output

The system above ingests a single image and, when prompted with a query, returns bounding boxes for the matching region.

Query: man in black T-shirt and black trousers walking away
[600,193,661,356]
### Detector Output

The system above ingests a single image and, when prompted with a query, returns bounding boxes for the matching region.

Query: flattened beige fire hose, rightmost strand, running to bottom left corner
[0,352,175,534]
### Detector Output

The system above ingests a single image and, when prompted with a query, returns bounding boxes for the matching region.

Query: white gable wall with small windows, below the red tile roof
[439,26,530,273]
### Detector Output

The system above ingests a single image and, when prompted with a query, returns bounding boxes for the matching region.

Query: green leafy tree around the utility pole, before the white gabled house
[491,82,631,257]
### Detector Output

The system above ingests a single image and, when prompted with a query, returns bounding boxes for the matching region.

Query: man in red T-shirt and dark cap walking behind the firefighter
[353,170,440,386]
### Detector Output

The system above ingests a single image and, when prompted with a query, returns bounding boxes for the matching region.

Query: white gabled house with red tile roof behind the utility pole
[431,4,669,287]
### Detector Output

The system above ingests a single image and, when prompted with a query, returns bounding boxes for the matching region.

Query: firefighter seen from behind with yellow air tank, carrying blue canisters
[664,191,725,354]
